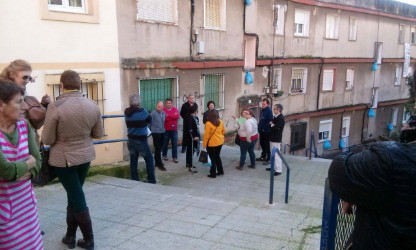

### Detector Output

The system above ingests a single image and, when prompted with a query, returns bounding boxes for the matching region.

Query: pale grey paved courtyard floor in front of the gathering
[35,146,330,250]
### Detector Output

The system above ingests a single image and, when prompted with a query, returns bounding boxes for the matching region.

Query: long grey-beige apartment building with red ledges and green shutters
[117,0,416,154]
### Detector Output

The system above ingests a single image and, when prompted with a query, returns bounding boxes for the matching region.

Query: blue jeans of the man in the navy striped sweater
[127,138,156,183]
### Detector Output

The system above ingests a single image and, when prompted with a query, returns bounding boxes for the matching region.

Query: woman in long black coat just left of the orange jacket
[182,106,200,173]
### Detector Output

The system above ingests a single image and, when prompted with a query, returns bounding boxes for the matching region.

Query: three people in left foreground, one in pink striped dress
[0,60,103,249]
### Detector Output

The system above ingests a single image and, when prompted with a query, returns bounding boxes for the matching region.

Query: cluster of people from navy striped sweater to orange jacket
[124,94,225,178]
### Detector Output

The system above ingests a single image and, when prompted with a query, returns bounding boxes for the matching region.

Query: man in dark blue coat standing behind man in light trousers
[256,98,273,163]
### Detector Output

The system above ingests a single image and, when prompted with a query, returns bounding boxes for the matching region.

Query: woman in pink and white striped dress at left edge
[0,79,43,250]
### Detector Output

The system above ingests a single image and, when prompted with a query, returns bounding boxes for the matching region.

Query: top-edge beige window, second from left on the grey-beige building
[204,0,226,30]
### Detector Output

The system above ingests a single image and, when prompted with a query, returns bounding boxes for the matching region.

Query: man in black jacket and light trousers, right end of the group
[266,104,285,176]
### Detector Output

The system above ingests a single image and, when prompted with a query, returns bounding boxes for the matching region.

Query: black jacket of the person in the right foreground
[328,142,416,250]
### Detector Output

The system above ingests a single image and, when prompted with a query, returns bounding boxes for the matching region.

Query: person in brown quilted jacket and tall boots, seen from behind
[42,70,103,249]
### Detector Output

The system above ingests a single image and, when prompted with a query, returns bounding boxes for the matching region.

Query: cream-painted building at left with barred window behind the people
[0,0,124,164]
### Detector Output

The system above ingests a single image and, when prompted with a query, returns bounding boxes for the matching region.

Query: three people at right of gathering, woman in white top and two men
[233,98,285,176]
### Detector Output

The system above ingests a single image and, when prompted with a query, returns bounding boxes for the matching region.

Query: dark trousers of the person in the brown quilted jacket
[54,162,90,213]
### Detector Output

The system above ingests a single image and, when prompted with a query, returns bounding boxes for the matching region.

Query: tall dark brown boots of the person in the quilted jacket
[62,207,94,250]
